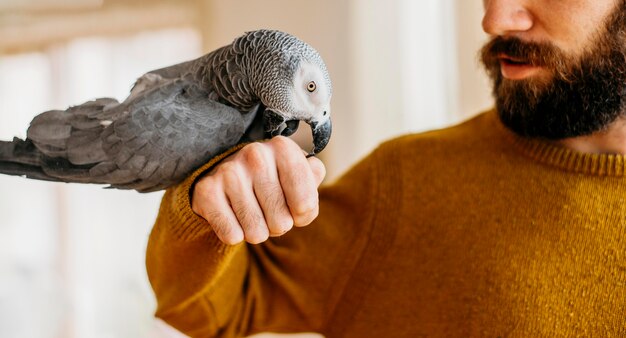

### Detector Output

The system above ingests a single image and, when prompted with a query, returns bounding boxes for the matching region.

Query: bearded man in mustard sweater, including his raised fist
[147,0,626,337]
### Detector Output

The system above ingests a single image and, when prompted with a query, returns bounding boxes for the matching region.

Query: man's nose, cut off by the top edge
[482,0,533,36]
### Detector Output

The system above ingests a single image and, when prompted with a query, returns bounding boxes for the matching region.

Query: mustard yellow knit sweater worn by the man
[147,112,626,338]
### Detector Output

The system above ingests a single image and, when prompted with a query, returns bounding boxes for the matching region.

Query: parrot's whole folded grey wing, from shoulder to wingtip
[29,79,251,192]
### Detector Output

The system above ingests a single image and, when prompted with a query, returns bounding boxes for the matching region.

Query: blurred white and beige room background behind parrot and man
[0,0,491,338]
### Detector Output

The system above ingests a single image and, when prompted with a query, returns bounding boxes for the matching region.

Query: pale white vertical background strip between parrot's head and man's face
[348,0,458,165]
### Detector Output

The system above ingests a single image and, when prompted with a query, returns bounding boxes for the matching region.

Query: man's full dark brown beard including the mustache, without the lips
[481,1,626,140]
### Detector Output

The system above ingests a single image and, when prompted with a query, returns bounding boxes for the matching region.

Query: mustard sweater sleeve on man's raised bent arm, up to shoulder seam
[146,147,378,337]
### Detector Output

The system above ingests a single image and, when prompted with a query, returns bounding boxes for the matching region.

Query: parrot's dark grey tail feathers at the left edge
[0,137,59,181]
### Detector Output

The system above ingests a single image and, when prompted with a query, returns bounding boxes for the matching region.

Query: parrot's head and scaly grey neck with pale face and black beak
[243,31,332,154]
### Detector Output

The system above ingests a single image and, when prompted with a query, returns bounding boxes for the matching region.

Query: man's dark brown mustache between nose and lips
[481,36,565,68]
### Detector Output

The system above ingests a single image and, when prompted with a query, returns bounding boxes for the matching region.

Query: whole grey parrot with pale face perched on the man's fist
[0,30,332,192]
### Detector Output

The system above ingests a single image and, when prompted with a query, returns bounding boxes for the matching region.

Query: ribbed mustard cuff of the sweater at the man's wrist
[161,144,246,240]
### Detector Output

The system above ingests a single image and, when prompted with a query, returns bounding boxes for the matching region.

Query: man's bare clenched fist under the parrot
[191,136,326,244]
